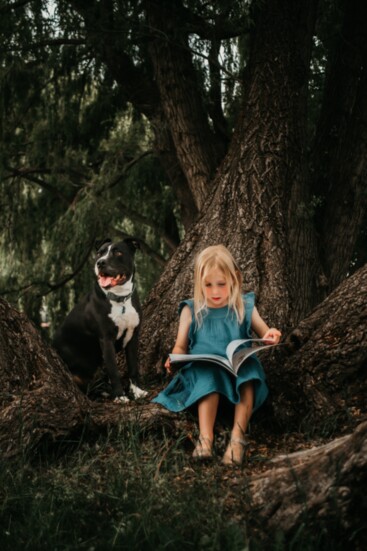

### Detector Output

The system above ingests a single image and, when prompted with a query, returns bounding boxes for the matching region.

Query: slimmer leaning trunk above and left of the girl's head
[146,0,220,211]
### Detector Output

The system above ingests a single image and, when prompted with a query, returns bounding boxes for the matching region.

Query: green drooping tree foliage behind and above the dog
[0,2,178,330]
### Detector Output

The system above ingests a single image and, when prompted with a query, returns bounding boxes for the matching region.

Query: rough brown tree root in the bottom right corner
[249,422,367,549]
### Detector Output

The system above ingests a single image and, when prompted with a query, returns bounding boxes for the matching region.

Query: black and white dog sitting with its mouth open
[54,239,147,402]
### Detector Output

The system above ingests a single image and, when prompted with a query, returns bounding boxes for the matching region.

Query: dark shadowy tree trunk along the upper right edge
[314,0,367,296]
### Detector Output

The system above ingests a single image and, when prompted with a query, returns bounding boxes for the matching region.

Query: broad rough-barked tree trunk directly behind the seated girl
[141,1,317,371]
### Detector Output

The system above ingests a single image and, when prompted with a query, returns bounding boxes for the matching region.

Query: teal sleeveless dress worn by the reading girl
[152,292,268,412]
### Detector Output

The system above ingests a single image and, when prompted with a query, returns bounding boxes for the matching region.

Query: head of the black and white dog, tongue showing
[94,239,139,291]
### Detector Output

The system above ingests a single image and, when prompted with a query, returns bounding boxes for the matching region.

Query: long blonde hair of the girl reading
[194,245,245,327]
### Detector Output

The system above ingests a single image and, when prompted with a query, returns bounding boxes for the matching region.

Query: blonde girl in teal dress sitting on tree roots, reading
[153,245,281,465]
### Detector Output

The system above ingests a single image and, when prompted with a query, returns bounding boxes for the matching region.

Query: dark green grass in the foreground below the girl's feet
[0,425,362,551]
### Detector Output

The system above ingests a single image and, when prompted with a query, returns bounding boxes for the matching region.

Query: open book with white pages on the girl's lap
[169,339,280,377]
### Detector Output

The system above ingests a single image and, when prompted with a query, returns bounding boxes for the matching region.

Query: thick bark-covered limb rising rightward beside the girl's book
[267,265,367,433]
